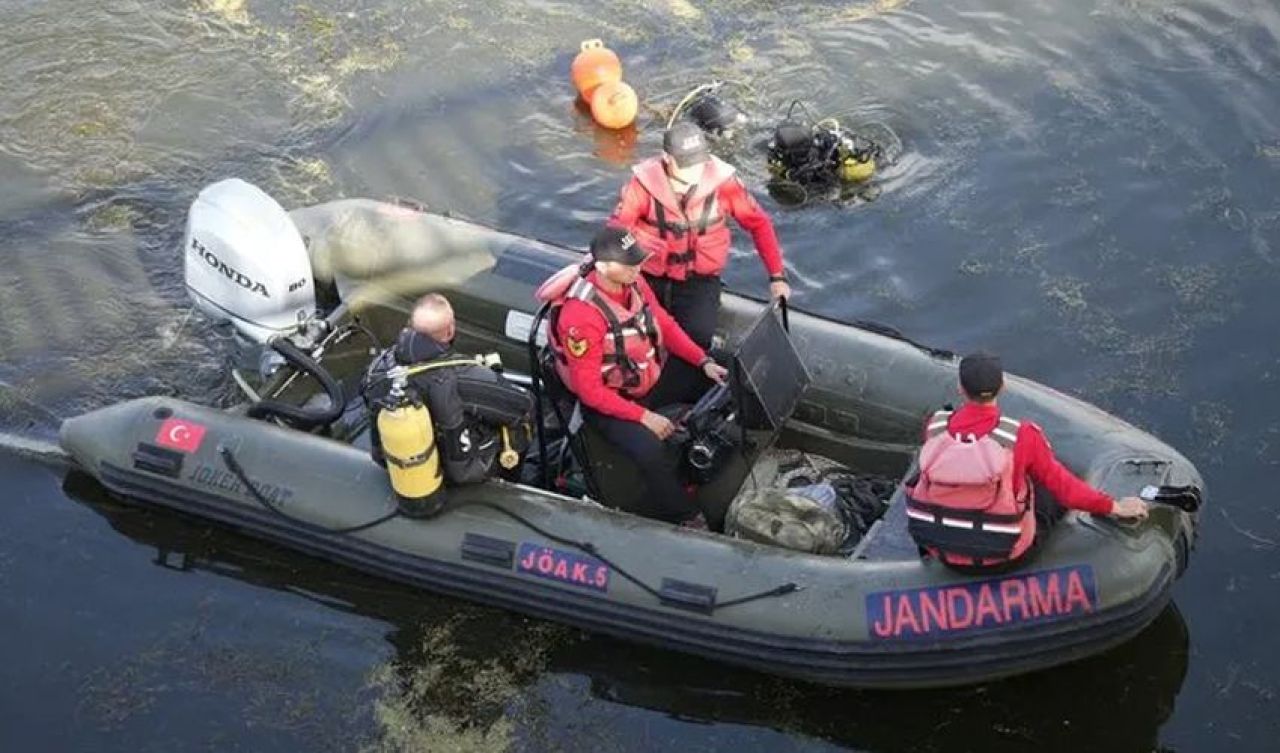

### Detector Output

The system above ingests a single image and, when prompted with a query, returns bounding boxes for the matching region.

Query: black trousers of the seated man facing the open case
[582,364,710,522]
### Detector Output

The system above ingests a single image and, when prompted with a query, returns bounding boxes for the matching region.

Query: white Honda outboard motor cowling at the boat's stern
[183,178,316,343]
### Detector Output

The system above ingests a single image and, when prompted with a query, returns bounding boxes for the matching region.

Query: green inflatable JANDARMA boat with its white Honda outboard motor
[61,179,1202,688]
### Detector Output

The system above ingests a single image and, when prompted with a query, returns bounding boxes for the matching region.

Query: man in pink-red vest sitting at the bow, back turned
[906,353,1147,572]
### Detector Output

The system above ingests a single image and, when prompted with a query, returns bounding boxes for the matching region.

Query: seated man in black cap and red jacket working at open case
[538,227,727,528]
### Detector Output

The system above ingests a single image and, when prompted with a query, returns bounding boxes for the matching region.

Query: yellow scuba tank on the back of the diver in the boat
[378,377,444,502]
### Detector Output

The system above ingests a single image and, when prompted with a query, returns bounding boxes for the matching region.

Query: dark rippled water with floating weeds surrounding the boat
[0,0,1280,752]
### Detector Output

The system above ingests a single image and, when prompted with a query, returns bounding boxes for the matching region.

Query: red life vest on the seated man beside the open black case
[536,264,666,398]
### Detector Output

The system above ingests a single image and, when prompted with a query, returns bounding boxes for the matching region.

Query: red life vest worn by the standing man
[631,156,733,279]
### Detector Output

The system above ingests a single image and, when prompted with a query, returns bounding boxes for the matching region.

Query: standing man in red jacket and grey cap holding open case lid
[609,120,791,348]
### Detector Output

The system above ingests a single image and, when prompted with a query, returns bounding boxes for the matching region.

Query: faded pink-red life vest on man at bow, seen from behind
[906,411,1036,566]
